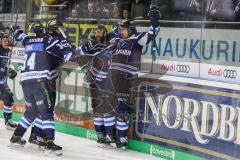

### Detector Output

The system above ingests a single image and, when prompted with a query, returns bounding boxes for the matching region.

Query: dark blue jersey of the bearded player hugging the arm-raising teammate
[78,36,113,92]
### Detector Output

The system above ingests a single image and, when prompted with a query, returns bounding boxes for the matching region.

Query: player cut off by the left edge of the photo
[0,32,17,129]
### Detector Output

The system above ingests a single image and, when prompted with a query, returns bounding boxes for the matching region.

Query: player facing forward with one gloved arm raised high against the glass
[110,6,160,149]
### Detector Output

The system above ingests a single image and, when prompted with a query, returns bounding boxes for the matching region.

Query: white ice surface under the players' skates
[0,119,159,160]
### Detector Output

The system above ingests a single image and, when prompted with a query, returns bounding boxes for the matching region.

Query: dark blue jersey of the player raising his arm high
[110,27,159,74]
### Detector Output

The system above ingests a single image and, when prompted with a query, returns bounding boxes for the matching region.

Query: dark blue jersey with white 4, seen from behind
[16,33,71,82]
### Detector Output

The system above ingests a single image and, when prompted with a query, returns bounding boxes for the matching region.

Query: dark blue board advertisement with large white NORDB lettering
[134,81,240,160]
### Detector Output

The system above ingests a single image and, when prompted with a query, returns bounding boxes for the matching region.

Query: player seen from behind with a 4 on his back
[10,22,72,154]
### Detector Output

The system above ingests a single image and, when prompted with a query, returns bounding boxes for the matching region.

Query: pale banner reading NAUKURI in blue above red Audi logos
[138,27,240,84]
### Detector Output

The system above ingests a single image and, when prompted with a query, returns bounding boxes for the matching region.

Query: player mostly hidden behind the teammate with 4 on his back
[29,20,72,149]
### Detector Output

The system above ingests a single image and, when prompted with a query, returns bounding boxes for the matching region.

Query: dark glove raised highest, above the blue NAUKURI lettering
[148,4,161,28]
